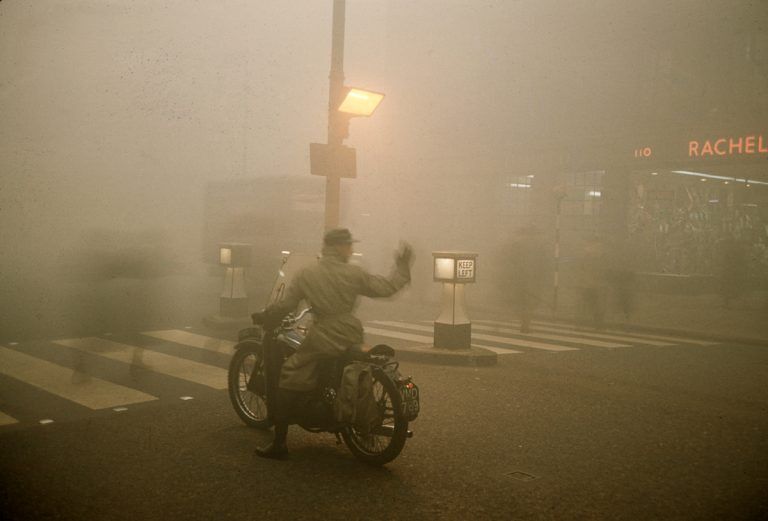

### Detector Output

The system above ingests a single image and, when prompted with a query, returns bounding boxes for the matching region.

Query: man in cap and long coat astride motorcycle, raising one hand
[253,228,413,459]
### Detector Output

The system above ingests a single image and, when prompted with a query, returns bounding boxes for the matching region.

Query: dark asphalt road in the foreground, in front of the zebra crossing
[0,345,768,521]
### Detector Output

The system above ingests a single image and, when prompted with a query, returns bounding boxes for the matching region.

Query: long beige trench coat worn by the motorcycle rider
[266,248,411,391]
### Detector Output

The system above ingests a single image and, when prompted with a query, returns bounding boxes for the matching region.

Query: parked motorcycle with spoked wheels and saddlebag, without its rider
[228,308,420,465]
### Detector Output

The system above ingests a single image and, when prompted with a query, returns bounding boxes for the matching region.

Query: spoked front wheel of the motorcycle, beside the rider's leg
[228,344,272,430]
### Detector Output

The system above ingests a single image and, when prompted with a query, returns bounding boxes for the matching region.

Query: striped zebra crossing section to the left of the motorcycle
[0,330,236,428]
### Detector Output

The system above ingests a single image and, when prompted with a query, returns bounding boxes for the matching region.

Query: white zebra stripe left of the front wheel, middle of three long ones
[55,337,227,389]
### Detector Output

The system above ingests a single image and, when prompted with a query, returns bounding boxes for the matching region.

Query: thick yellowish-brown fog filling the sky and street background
[0,0,768,340]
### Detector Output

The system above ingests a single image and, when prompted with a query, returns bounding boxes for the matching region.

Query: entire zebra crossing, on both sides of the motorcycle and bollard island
[0,320,713,428]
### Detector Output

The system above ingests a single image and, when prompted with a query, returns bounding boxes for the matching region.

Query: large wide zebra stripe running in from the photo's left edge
[0,346,157,409]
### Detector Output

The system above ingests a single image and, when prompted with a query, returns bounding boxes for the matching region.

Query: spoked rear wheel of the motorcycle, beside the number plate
[341,371,408,466]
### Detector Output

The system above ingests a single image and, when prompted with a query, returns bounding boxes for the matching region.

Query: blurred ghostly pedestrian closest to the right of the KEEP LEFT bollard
[509,223,548,333]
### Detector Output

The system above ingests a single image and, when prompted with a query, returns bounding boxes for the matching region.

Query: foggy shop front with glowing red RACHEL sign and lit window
[562,128,768,293]
